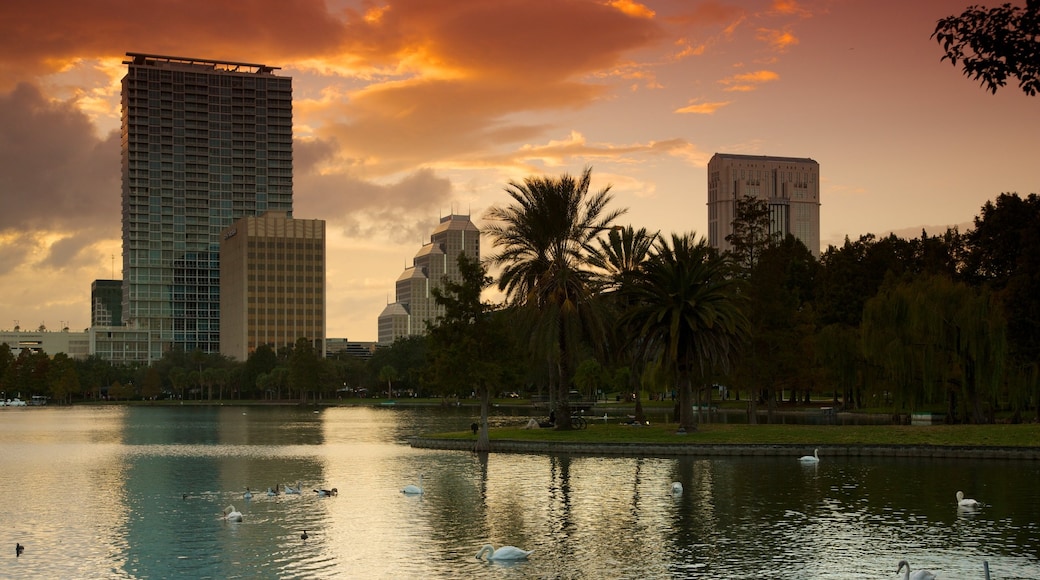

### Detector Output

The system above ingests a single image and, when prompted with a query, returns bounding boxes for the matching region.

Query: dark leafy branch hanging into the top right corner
[932,0,1040,97]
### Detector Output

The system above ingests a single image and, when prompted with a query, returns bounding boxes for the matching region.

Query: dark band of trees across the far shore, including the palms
[0,191,1040,423]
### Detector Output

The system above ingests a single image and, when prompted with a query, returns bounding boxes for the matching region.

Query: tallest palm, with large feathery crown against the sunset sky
[485,167,627,429]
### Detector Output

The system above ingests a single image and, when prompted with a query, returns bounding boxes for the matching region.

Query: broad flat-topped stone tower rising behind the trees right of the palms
[708,153,820,258]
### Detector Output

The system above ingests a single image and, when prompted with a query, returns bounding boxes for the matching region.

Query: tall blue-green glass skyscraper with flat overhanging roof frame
[122,52,292,361]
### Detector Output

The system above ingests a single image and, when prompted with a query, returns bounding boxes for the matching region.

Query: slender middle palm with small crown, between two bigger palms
[591,226,657,423]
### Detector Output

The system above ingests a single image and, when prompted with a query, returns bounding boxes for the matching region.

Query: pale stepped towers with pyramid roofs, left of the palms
[378,214,480,344]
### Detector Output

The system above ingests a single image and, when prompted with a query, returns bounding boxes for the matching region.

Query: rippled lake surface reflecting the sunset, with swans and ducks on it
[0,406,1040,579]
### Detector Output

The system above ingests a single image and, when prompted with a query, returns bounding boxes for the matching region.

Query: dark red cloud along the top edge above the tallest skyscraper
[0,0,344,89]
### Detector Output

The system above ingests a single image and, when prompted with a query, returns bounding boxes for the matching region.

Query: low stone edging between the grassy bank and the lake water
[408,437,1040,460]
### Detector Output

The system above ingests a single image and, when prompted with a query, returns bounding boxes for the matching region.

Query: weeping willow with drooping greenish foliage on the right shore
[861,275,1008,423]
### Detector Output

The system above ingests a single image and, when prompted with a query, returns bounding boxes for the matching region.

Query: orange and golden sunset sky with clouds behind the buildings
[0,0,1040,341]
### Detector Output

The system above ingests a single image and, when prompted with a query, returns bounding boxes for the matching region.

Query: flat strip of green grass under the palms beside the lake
[425,421,1040,447]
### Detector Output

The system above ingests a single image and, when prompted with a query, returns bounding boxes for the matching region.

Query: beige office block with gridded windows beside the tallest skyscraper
[220,211,326,361]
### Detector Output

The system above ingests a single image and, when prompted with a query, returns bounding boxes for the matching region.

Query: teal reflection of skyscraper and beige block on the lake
[116,406,324,578]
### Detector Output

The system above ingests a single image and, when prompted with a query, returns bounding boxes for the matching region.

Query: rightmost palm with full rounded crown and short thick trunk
[622,234,749,431]
